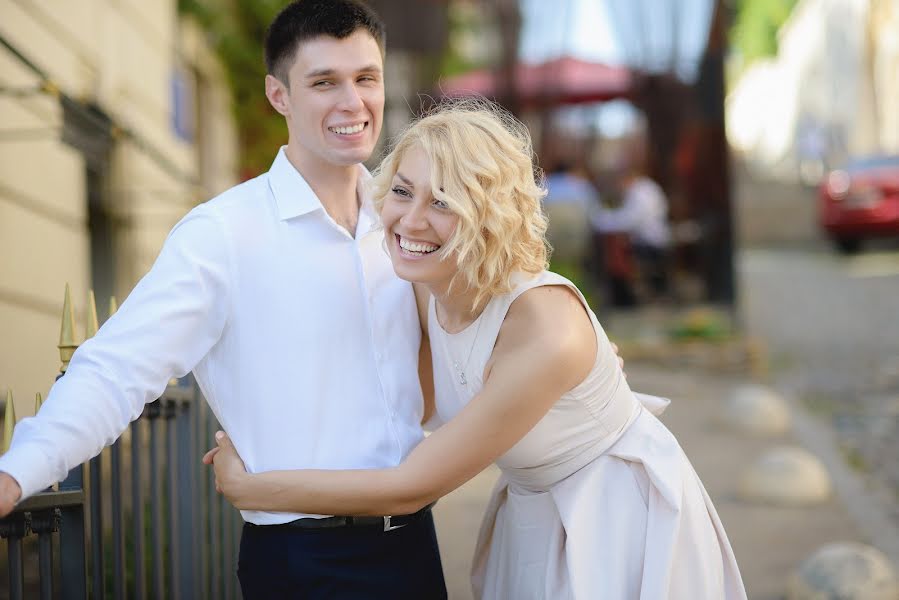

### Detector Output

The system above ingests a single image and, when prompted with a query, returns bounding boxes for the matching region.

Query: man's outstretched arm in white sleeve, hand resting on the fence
[0,206,232,516]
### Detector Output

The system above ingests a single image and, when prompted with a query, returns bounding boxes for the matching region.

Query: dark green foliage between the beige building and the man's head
[178,0,287,177]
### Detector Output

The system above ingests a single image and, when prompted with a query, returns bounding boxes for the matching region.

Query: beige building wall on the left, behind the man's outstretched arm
[0,0,237,417]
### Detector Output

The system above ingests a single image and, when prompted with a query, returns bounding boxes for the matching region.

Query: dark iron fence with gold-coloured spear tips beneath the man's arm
[0,288,242,600]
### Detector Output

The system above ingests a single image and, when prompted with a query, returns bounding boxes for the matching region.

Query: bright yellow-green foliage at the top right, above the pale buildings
[731,0,796,65]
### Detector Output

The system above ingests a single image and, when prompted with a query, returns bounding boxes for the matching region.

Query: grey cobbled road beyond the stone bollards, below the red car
[737,241,899,561]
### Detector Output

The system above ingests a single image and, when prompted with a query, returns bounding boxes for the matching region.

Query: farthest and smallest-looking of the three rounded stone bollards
[722,384,790,436]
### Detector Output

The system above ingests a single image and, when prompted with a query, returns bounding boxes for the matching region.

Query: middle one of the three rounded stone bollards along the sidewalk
[739,446,831,506]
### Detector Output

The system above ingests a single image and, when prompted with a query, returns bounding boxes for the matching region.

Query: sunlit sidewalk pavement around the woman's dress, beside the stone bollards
[435,363,872,600]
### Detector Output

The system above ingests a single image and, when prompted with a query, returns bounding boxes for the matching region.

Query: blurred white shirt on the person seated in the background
[591,176,671,248]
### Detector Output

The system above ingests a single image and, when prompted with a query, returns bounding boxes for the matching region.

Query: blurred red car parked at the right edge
[819,156,899,254]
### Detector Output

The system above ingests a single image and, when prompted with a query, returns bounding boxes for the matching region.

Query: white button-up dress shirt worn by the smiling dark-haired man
[0,148,422,524]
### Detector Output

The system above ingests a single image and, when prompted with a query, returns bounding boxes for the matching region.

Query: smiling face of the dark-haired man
[269,29,384,168]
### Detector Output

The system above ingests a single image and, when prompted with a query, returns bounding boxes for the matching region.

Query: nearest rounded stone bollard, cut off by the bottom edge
[787,543,899,600]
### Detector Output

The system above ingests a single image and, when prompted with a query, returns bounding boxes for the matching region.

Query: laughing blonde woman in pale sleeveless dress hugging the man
[205,102,746,600]
